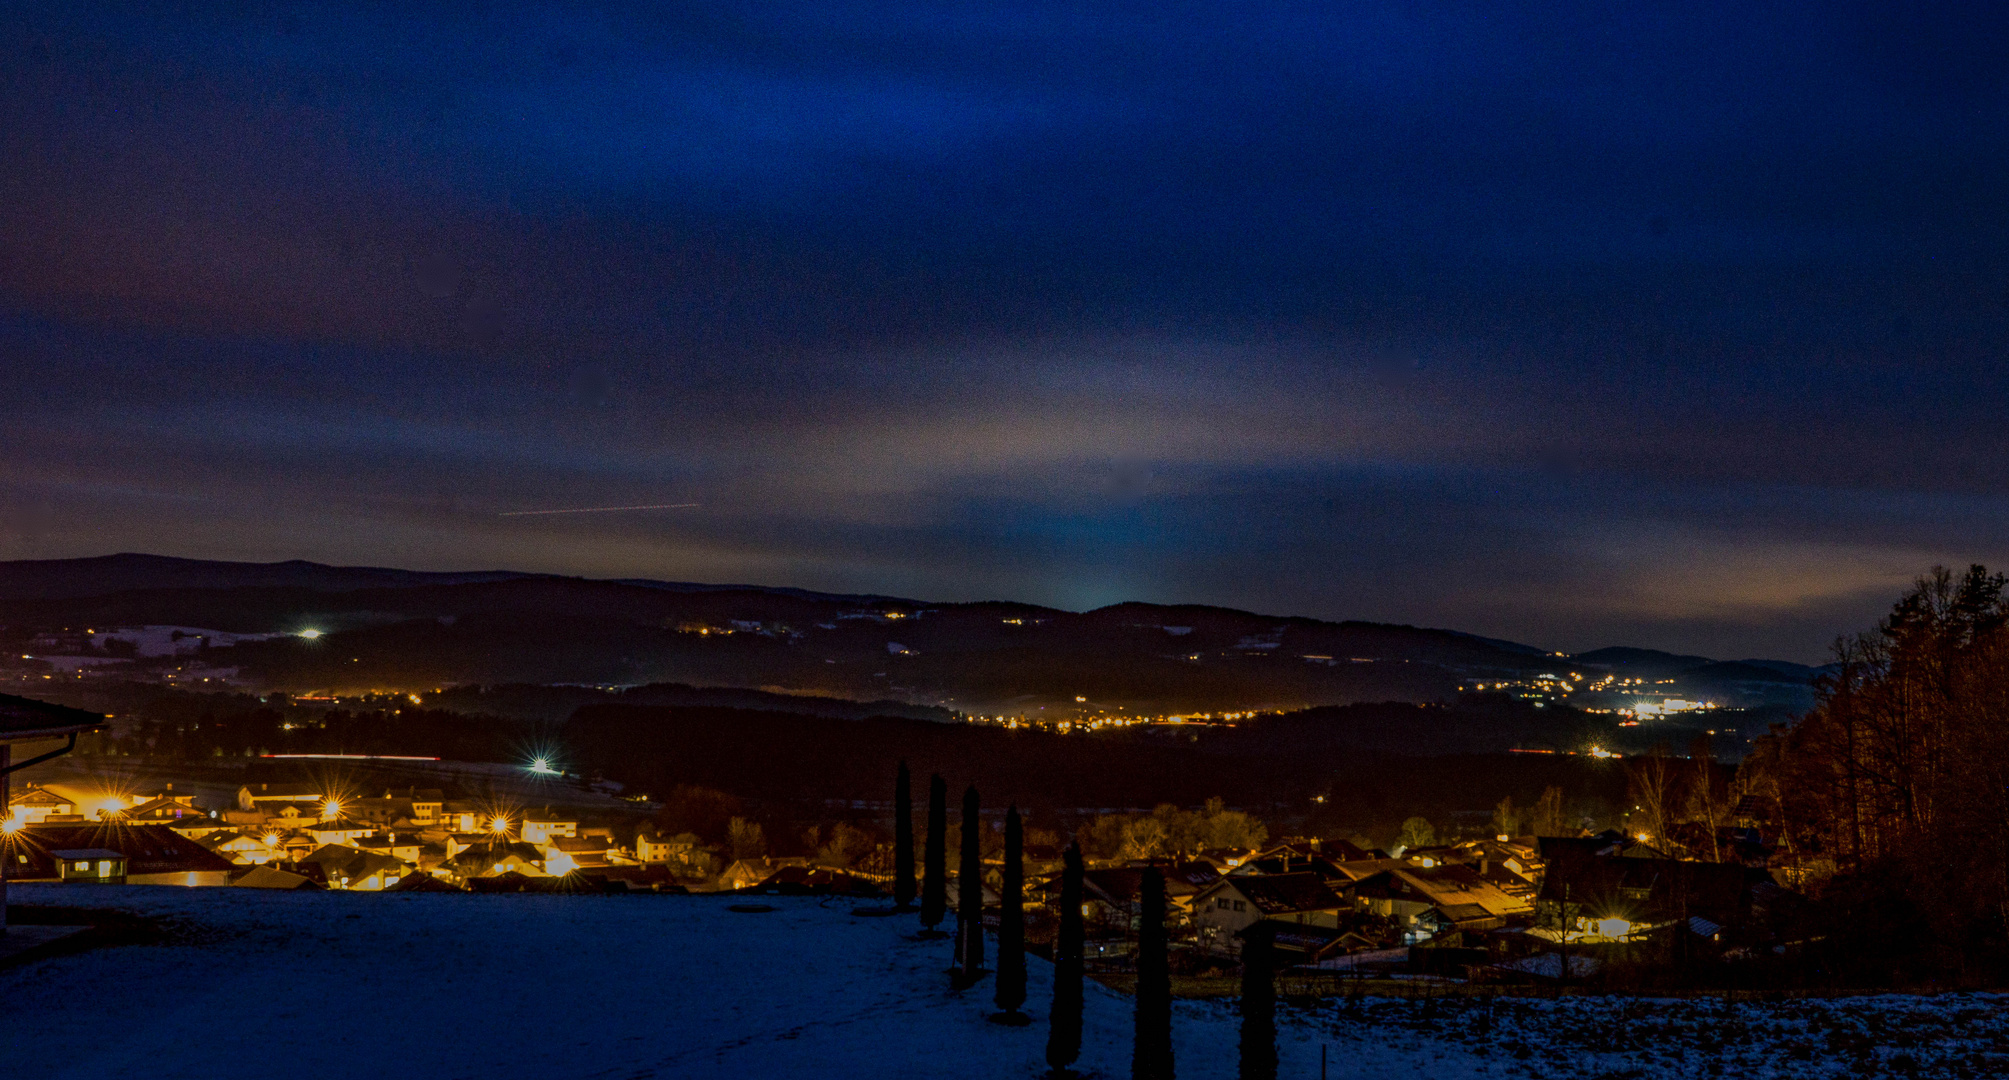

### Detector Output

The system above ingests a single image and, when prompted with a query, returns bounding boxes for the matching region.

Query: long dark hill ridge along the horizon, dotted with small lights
[0,554,1804,717]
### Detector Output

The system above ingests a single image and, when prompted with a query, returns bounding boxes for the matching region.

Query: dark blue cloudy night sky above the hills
[0,0,2009,660]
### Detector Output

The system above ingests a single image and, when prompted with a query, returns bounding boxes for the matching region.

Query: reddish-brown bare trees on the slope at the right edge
[1740,566,2009,982]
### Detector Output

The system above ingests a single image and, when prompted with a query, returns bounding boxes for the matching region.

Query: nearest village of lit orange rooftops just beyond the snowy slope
[0,754,1808,984]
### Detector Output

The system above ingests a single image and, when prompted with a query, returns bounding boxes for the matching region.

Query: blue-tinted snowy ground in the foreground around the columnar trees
[0,885,2009,1080]
